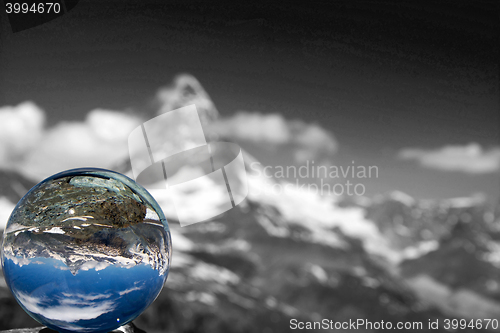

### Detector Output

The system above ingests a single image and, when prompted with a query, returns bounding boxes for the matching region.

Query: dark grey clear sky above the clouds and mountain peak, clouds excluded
[0,0,500,197]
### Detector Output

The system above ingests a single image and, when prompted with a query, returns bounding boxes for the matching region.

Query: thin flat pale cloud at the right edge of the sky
[398,143,500,174]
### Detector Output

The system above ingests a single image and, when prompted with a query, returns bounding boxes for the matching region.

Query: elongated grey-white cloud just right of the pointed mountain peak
[209,111,338,163]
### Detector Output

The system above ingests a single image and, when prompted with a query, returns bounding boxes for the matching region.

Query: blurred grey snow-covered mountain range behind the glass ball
[0,77,500,333]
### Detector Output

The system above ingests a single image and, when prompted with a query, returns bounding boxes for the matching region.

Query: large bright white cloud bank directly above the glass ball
[0,102,141,180]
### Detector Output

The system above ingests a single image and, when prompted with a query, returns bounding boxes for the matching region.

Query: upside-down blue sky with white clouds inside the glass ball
[5,258,164,331]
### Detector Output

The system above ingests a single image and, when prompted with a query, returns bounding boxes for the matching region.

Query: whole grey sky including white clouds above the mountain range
[0,0,500,201]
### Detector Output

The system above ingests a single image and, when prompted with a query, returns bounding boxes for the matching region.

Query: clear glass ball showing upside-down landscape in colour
[1,169,172,332]
